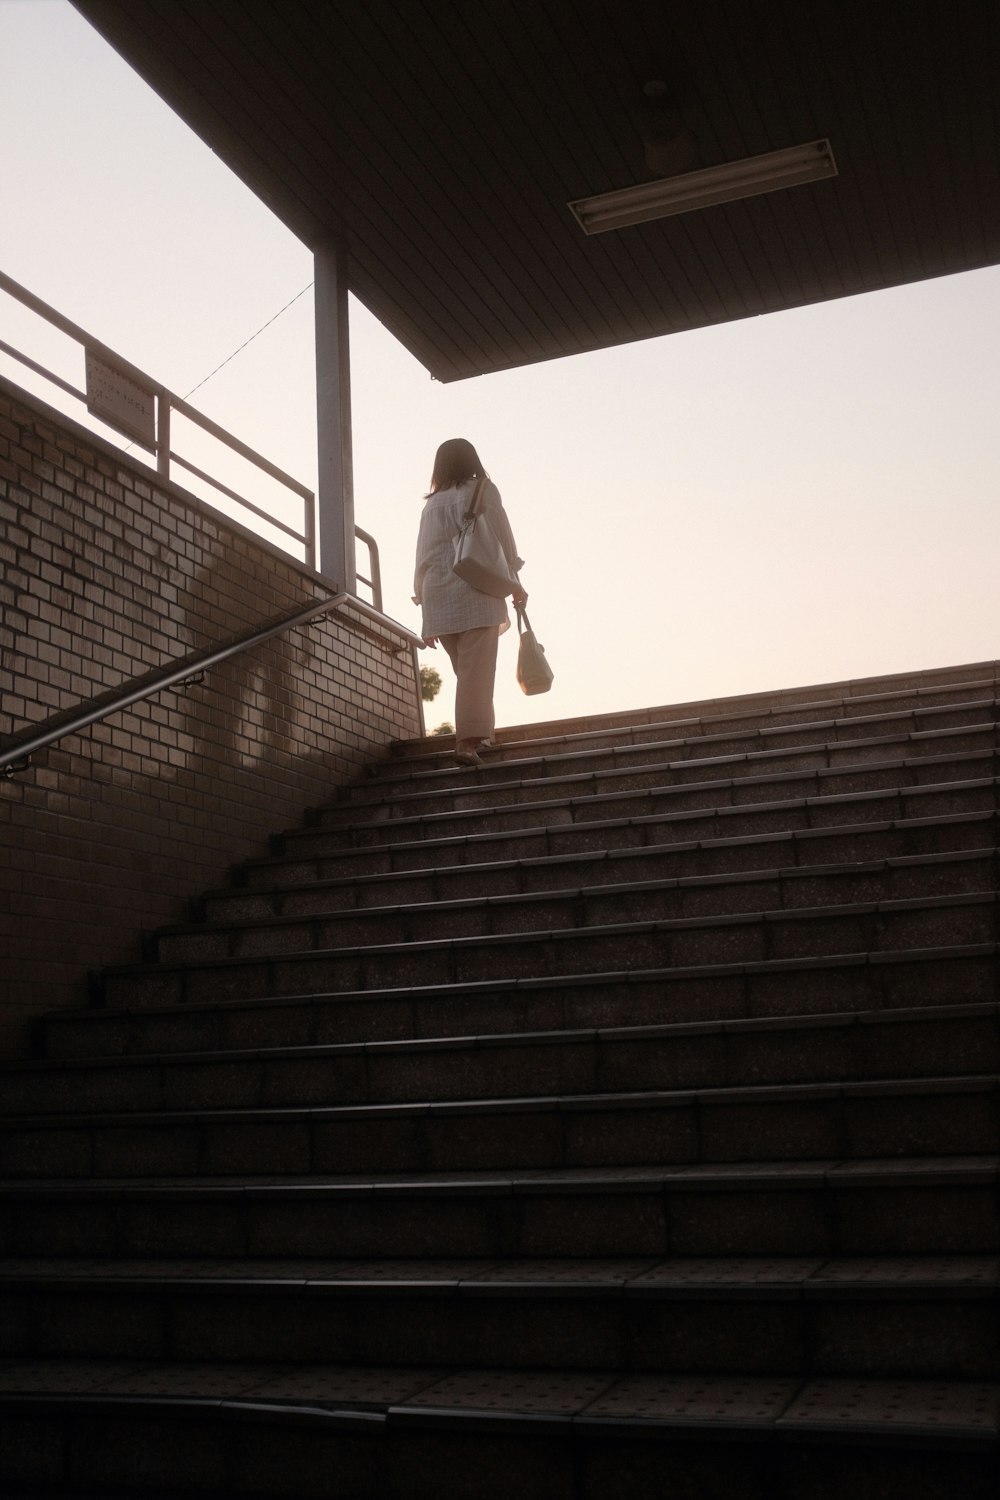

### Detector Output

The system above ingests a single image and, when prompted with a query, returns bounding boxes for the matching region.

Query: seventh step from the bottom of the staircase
[95,891,1000,1007]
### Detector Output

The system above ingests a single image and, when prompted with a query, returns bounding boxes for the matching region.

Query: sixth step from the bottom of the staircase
[52,944,1000,1058]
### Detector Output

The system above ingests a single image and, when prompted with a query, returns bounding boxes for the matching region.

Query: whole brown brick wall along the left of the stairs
[0,380,421,1055]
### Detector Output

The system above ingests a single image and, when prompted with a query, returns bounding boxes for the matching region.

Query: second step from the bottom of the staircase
[0,1256,1000,1389]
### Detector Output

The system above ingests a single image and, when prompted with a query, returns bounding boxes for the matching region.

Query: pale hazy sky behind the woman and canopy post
[0,0,1000,728]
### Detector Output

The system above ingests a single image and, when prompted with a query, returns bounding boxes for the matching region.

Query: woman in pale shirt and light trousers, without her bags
[414,438,528,765]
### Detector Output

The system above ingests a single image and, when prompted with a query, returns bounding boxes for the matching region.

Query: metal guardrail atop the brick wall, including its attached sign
[0,272,382,612]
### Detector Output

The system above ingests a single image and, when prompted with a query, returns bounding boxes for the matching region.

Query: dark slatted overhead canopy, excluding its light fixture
[75,0,1000,381]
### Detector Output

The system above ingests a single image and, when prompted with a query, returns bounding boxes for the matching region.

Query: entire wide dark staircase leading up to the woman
[0,663,1000,1500]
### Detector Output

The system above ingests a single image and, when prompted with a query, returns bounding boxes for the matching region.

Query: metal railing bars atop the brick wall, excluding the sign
[0,272,382,611]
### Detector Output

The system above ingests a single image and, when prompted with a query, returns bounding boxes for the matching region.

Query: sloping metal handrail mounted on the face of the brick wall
[0,594,423,777]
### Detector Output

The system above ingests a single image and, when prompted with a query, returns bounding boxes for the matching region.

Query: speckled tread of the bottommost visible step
[0,1361,1000,1446]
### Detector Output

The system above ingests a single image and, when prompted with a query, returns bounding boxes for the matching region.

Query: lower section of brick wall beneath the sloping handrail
[0,573,399,1053]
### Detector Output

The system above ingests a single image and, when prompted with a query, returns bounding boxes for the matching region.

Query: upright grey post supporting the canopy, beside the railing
[315,245,358,594]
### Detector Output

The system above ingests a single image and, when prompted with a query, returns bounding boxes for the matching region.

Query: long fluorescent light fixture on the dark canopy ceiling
[570,141,837,234]
